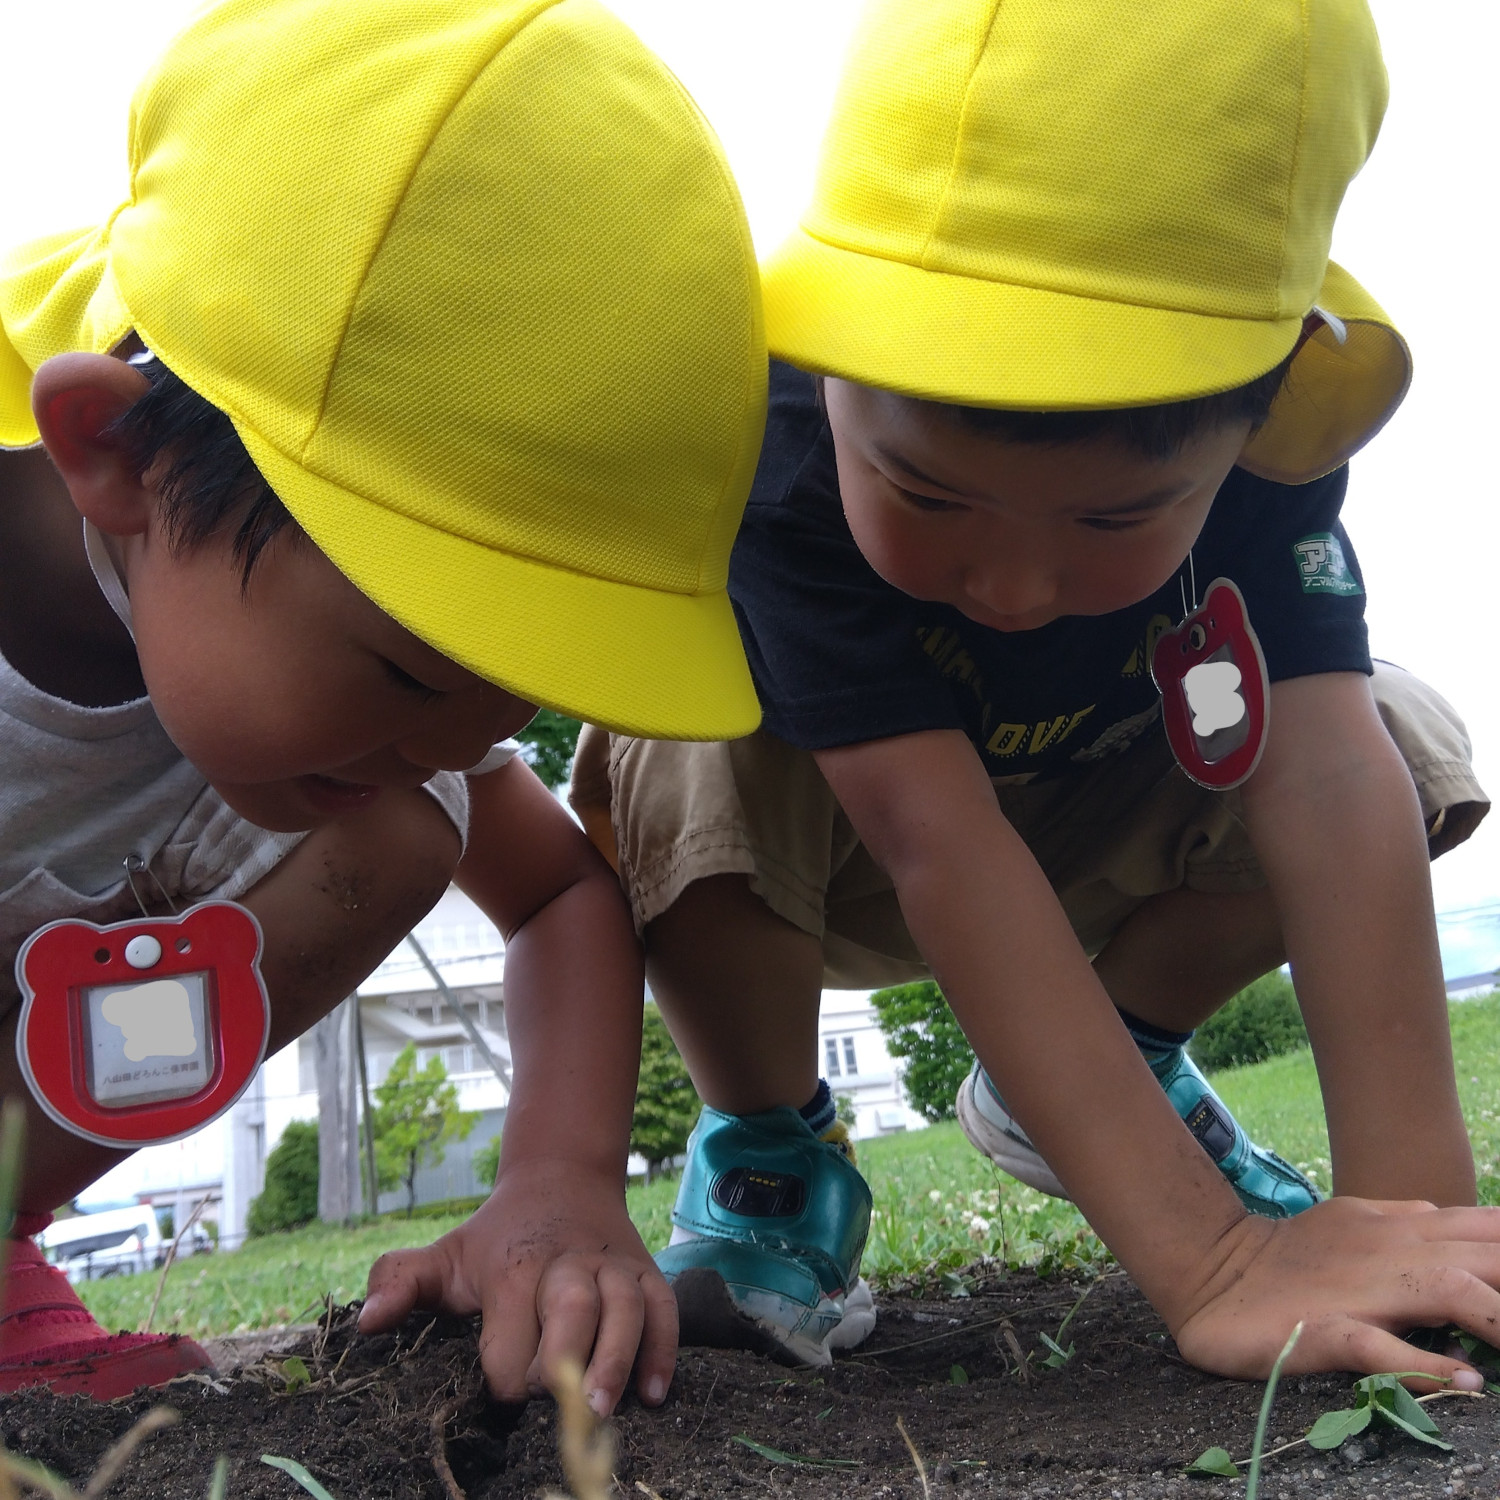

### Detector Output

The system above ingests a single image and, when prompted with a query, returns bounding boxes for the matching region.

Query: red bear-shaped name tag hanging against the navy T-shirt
[1151,578,1271,792]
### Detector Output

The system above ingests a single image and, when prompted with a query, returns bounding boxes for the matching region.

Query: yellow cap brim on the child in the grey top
[239,428,761,740]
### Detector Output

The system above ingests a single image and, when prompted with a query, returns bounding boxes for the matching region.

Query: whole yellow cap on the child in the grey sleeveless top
[0,0,765,740]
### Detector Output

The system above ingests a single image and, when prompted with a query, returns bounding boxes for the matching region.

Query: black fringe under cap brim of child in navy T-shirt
[818,351,1295,459]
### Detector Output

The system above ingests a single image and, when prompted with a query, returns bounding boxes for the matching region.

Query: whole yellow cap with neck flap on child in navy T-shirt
[762,0,1410,482]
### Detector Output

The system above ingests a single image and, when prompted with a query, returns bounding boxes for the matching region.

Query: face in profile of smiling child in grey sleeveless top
[120,528,536,831]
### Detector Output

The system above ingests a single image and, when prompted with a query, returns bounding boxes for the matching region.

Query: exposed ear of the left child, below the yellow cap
[32,354,152,537]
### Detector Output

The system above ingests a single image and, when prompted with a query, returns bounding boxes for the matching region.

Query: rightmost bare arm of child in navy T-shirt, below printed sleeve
[1244,672,1475,1205]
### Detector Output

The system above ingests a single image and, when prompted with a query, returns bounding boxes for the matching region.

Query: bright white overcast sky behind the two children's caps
[11,0,1500,972]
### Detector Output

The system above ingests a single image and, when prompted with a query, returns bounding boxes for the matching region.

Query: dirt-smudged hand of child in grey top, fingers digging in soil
[360,1161,677,1416]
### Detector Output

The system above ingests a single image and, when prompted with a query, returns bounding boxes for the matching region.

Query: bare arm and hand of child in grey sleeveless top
[362,762,677,1413]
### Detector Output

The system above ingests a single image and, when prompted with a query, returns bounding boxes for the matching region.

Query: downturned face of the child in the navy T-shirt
[824,380,1250,630]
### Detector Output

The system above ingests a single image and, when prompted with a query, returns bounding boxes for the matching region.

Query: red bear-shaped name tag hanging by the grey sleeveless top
[15,902,270,1148]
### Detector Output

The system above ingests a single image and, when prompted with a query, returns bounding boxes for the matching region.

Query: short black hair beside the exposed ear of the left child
[108,359,303,587]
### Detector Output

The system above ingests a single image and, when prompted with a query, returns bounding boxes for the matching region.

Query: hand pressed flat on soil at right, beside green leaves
[1172,1199,1500,1391]
